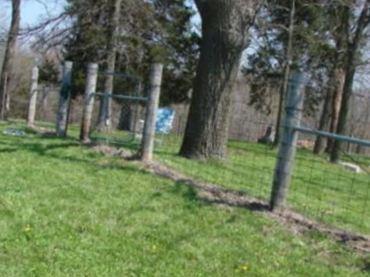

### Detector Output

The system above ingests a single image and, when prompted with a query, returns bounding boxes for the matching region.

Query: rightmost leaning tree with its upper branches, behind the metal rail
[330,0,370,163]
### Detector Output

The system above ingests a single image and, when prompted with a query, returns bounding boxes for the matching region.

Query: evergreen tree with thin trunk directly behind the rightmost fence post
[243,0,328,145]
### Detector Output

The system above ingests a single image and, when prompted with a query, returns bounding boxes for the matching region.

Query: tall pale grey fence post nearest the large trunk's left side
[141,63,163,162]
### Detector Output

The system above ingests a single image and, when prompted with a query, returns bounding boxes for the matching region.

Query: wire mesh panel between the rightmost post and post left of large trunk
[156,111,277,201]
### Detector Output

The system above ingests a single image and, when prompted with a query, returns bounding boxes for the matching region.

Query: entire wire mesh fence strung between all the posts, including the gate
[2,64,370,234]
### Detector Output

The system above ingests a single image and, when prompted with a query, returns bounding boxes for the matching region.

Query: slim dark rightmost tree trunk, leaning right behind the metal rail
[330,1,370,163]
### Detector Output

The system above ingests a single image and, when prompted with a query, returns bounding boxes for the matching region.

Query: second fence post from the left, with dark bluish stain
[56,61,73,137]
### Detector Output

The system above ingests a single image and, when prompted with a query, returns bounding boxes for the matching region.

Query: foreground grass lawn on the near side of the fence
[0,124,370,276]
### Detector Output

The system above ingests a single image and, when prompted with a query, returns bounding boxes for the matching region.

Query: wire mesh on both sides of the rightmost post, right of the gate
[152,78,370,234]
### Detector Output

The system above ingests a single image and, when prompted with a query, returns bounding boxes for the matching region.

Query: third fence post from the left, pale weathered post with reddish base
[80,63,98,143]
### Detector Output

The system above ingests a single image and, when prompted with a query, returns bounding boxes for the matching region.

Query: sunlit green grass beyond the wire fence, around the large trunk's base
[157,137,370,235]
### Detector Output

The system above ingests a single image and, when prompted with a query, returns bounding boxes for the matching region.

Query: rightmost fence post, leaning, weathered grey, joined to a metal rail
[270,72,304,210]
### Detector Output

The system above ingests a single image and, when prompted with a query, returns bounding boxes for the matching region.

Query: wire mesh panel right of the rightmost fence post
[288,104,370,234]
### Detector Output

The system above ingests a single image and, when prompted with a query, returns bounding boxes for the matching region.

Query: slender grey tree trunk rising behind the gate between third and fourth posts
[97,0,122,131]
